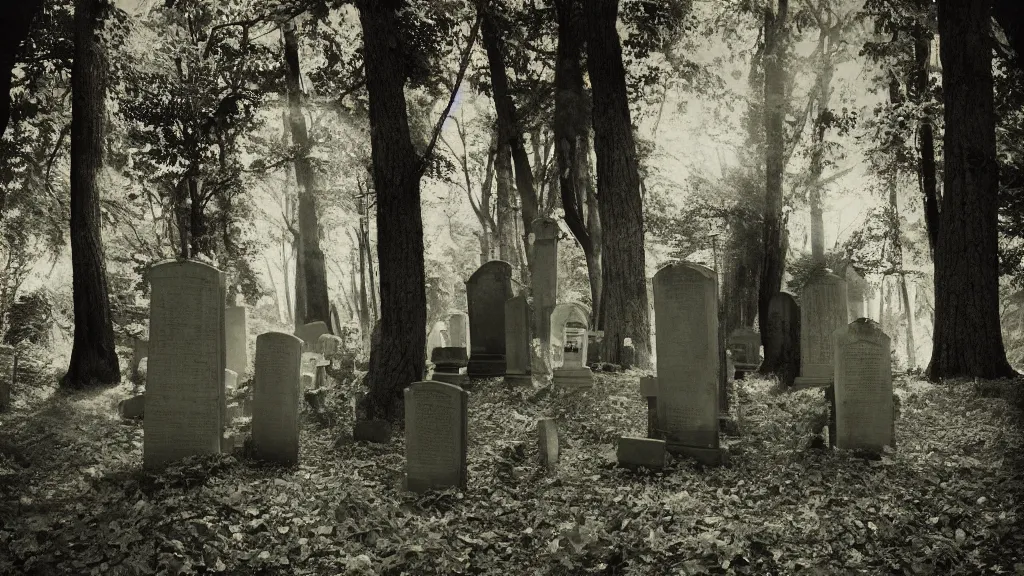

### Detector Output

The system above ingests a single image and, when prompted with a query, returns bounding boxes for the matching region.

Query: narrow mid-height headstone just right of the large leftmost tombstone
[252,332,303,465]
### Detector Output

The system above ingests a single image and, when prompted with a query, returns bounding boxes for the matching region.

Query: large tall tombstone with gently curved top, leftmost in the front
[142,260,227,468]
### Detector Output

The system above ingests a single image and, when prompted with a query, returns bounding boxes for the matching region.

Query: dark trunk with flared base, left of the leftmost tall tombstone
[61,0,121,388]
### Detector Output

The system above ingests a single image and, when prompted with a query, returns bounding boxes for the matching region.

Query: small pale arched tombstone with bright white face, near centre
[551,302,594,388]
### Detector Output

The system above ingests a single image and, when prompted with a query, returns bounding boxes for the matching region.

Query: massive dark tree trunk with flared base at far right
[928,0,1017,379]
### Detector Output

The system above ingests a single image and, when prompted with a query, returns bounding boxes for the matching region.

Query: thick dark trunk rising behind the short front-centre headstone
[358,0,427,421]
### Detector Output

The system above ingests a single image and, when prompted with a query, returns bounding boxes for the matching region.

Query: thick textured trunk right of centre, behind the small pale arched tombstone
[586,0,651,369]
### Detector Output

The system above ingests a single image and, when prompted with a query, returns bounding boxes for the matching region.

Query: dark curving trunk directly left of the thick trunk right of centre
[554,0,603,330]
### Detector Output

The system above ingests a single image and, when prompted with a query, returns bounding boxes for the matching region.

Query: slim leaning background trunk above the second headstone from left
[282,20,331,327]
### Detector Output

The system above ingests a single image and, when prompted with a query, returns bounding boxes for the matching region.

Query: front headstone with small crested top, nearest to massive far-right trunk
[833,318,895,452]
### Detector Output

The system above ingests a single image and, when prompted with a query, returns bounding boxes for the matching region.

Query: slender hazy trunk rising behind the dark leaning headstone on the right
[758,0,790,349]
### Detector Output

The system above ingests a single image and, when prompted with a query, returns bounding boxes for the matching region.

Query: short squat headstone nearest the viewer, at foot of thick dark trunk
[406,380,469,493]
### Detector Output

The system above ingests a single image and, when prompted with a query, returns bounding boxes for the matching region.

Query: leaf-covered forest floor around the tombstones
[0,350,1024,576]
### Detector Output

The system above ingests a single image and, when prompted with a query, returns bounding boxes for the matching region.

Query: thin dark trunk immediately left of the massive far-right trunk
[910,0,939,259]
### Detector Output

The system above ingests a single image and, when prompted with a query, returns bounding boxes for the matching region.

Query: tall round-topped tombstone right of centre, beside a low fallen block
[654,262,724,464]
